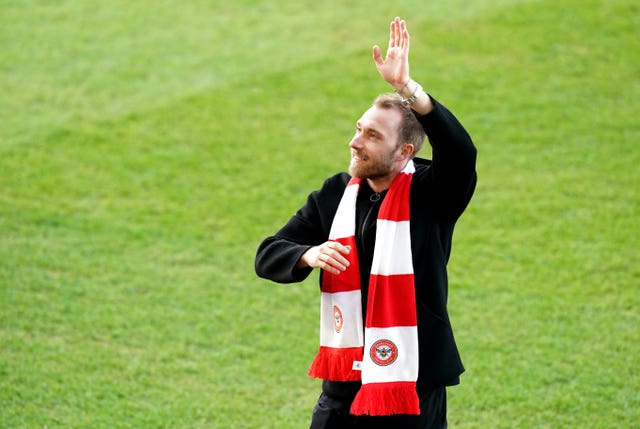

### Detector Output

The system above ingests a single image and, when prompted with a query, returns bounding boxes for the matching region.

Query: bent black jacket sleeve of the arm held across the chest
[255,176,340,283]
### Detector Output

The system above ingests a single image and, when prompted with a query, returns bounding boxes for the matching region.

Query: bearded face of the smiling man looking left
[349,106,401,179]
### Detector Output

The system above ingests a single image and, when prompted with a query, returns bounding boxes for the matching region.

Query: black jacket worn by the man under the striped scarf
[255,100,476,393]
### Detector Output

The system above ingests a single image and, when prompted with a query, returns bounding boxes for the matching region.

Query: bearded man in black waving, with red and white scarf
[255,18,476,429]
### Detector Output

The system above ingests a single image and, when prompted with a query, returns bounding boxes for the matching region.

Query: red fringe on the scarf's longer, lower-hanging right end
[351,382,420,416]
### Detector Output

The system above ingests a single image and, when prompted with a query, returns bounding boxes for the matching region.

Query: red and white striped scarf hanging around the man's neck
[309,161,420,416]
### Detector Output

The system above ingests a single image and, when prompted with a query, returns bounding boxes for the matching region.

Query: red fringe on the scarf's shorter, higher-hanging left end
[309,346,363,381]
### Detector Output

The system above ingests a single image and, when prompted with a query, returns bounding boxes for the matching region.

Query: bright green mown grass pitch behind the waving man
[0,0,640,429]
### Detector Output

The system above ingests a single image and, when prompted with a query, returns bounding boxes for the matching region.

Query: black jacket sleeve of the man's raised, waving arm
[418,99,477,221]
